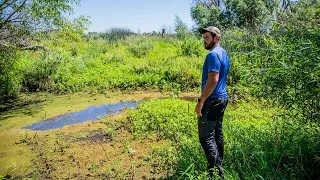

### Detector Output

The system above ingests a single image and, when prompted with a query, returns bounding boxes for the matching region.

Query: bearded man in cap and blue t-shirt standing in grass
[196,26,230,178]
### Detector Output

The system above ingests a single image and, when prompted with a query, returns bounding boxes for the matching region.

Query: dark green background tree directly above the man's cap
[191,0,279,29]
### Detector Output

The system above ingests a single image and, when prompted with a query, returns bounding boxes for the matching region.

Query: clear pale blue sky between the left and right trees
[73,0,194,33]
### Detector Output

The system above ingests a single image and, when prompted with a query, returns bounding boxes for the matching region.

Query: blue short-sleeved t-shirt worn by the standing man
[201,46,230,98]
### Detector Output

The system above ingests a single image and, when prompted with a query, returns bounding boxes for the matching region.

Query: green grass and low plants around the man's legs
[129,99,319,179]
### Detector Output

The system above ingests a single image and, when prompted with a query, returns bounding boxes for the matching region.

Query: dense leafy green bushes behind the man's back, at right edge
[222,25,320,124]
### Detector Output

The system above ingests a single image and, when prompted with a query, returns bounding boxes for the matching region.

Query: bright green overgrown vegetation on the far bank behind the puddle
[20,36,205,92]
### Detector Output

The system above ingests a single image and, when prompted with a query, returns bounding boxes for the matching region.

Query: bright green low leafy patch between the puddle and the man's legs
[130,99,196,141]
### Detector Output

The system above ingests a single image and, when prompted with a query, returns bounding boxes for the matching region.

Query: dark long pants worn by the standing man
[198,98,228,175]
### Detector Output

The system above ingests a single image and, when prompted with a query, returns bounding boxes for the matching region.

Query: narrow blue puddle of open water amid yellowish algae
[25,101,139,131]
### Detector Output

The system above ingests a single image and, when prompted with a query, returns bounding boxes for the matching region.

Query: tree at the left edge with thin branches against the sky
[0,0,86,101]
